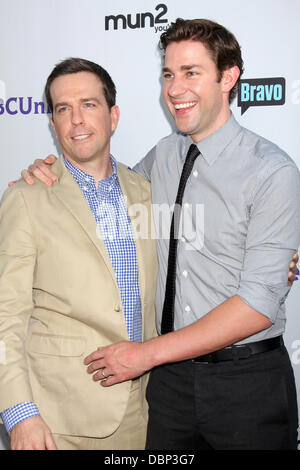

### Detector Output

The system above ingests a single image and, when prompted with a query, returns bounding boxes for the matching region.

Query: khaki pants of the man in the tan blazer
[53,380,147,450]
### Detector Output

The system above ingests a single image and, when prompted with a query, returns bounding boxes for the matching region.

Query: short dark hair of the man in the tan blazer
[45,57,116,113]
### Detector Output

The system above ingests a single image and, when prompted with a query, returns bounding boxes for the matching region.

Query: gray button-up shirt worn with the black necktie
[134,115,300,343]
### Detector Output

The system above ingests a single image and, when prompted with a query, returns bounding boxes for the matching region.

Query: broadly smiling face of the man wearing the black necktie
[163,40,239,142]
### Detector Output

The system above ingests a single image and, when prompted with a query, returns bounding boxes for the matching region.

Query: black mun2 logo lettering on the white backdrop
[105,3,169,33]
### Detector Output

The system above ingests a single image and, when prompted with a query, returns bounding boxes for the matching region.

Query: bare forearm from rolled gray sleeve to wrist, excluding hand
[143,296,271,370]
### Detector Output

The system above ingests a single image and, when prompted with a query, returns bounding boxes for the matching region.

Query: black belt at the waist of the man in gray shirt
[192,336,283,363]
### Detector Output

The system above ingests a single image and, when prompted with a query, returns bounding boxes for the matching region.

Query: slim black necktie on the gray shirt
[161,144,200,334]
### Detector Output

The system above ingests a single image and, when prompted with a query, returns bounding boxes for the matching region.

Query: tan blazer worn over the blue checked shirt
[0,159,157,437]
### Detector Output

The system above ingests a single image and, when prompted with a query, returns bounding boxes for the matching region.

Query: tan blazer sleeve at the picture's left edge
[0,187,36,411]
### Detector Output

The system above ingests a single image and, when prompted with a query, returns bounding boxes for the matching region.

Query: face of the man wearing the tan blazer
[50,72,119,169]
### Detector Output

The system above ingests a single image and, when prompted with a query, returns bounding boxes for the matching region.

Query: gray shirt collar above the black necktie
[186,114,241,166]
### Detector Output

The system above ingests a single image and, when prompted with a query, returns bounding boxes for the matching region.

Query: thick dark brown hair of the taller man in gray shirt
[160,18,244,103]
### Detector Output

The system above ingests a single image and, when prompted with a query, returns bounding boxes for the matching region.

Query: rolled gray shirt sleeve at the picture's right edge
[237,163,300,323]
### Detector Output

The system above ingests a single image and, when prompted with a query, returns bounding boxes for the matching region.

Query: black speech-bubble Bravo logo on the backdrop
[238,77,285,114]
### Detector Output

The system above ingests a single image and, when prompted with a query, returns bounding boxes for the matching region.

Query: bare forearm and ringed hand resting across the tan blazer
[84,296,271,387]
